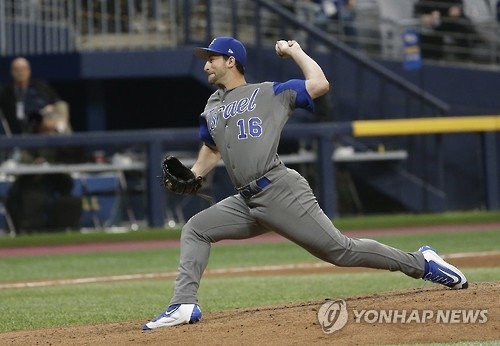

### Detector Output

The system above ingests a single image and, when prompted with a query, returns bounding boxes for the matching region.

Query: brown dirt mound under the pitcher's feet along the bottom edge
[0,282,500,345]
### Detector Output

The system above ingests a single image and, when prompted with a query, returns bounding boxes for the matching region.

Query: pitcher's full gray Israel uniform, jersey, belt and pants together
[170,80,425,304]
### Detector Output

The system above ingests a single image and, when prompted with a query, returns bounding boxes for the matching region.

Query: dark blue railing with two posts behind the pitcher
[0,123,352,227]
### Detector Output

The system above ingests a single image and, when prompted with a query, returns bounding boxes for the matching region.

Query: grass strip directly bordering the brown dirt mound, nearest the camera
[0,268,500,332]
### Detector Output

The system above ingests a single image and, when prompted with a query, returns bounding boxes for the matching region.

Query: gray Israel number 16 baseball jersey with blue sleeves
[200,79,313,187]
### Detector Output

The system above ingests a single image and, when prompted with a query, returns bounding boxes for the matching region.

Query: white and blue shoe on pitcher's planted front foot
[142,304,201,330]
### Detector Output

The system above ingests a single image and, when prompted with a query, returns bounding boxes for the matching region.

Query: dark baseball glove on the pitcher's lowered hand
[161,156,203,195]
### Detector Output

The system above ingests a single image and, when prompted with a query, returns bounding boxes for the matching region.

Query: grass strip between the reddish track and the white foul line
[0,231,500,282]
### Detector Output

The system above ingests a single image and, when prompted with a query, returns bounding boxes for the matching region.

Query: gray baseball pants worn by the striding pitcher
[170,165,425,304]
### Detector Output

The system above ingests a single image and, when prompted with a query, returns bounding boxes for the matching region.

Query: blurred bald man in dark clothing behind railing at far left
[0,57,81,232]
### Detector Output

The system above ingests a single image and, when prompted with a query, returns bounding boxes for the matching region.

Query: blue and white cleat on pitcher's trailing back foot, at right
[418,246,469,290]
